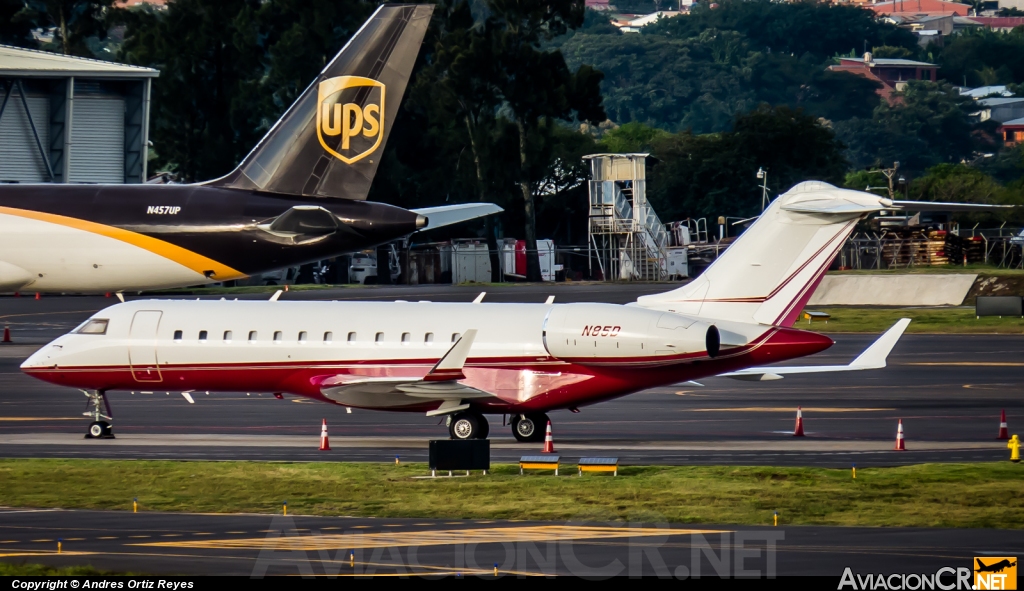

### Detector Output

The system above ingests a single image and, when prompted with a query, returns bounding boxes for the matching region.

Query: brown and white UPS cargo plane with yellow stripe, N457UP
[0,4,501,293]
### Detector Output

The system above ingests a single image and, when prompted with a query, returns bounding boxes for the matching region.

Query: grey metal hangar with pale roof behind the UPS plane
[0,45,160,183]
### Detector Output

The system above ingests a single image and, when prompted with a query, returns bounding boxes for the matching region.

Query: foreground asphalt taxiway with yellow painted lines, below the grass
[0,508,1024,583]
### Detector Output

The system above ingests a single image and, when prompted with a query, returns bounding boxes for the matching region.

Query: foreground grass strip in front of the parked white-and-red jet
[0,459,1024,529]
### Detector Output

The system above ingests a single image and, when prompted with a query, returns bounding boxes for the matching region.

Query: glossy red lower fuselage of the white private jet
[23,328,833,413]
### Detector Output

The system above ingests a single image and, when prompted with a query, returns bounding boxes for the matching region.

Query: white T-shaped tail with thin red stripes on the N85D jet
[637,181,1012,327]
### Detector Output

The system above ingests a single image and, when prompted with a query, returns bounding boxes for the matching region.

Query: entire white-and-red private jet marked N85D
[22,182,999,440]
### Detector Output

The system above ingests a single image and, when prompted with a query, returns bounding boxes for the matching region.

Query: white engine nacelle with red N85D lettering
[544,304,721,365]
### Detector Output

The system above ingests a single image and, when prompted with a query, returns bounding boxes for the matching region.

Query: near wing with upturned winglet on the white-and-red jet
[321,329,497,417]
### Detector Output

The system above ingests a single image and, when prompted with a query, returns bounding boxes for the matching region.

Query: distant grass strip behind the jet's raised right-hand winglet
[794,306,1024,335]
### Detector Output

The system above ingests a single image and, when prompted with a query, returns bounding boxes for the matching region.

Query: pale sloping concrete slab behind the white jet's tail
[807,273,978,306]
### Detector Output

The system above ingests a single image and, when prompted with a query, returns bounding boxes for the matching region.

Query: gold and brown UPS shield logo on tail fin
[316,76,385,164]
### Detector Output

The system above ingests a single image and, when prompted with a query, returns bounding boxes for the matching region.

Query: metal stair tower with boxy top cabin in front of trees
[584,154,669,281]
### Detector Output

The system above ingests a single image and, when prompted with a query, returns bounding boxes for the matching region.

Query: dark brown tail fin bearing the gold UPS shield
[205,4,433,200]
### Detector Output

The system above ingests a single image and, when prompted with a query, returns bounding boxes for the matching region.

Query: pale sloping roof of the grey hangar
[0,45,160,79]
